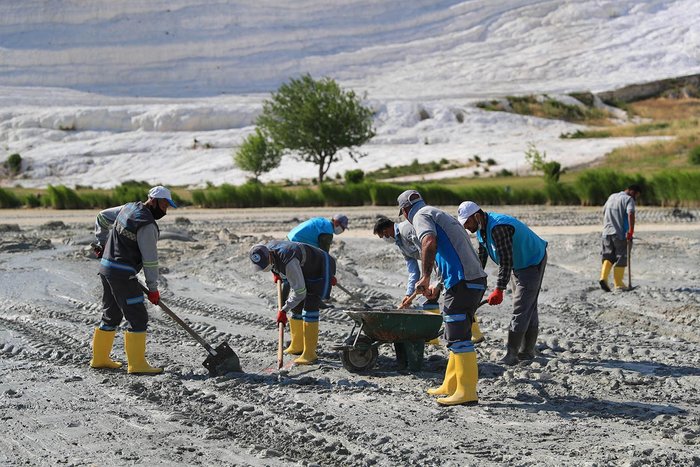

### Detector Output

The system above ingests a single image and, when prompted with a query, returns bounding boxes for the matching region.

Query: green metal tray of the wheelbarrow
[346,310,442,342]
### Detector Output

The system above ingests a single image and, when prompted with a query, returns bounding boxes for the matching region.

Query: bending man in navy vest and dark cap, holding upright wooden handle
[249,240,335,365]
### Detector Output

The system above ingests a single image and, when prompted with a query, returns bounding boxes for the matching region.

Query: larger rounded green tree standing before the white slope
[256,74,374,184]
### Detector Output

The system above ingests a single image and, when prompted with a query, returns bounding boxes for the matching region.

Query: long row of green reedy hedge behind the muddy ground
[0,169,700,209]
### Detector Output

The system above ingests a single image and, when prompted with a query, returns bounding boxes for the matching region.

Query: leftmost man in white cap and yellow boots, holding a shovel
[90,186,177,374]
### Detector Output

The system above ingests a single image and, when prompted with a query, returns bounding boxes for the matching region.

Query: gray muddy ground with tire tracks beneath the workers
[0,207,700,466]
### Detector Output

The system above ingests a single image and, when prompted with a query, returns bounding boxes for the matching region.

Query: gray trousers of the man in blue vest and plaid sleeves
[510,251,547,332]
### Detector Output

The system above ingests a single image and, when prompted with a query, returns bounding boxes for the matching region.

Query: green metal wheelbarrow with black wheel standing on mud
[333,310,442,373]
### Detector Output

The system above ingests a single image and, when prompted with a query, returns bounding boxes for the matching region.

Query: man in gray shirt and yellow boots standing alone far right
[598,185,642,292]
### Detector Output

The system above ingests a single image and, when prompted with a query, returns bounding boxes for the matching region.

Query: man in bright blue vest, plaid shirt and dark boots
[457,201,547,366]
